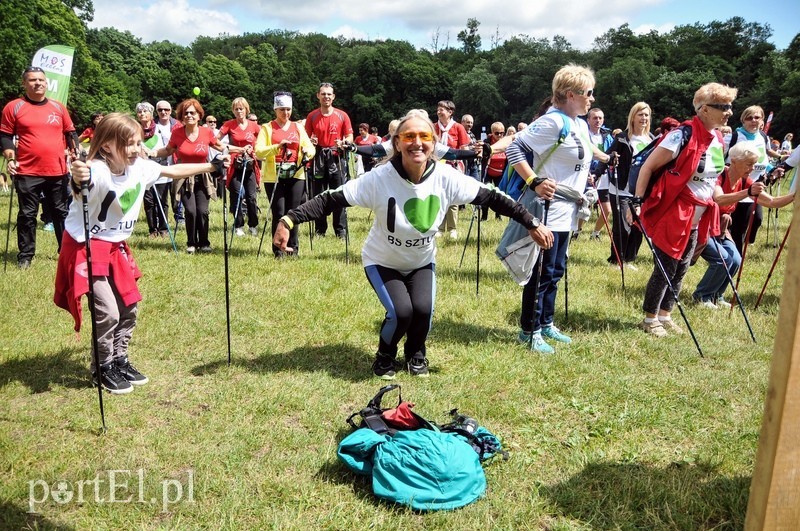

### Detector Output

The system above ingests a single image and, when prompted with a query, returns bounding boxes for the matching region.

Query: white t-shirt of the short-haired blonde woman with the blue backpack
[517,112,593,232]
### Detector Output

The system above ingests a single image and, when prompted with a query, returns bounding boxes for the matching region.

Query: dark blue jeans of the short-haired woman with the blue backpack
[519,231,569,332]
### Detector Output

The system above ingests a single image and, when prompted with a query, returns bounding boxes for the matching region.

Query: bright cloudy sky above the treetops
[90,0,800,50]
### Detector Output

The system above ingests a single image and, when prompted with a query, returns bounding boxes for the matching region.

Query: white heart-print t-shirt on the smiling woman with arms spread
[341,164,486,274]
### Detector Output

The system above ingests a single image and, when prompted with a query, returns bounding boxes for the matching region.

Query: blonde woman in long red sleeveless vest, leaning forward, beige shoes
[631,83,737,337]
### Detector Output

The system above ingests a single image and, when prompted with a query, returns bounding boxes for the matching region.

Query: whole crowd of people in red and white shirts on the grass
[0,65,800,393]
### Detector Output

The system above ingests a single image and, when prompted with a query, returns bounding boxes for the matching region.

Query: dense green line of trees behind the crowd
[0,0,800,141]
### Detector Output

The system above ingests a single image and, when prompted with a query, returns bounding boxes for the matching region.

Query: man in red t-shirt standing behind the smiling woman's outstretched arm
[306,83,353,238]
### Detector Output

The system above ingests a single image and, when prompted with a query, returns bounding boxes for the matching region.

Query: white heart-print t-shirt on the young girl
[64,159,163,242]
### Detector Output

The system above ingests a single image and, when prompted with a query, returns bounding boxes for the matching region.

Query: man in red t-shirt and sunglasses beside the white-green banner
[0,67,78,269]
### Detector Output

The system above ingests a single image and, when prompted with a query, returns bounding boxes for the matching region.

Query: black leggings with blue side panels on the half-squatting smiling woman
[364,264,436,360]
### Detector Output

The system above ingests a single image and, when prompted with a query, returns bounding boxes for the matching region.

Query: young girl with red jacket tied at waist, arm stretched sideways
[54,113,221,394]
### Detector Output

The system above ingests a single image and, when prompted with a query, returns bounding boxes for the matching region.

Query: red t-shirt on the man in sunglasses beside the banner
[0,98,75,178]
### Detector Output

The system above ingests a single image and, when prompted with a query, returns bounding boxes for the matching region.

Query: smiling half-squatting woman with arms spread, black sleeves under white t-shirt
[273,113,552,380]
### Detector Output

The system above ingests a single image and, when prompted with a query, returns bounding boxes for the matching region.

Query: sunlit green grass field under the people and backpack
[0,188,789,530]
